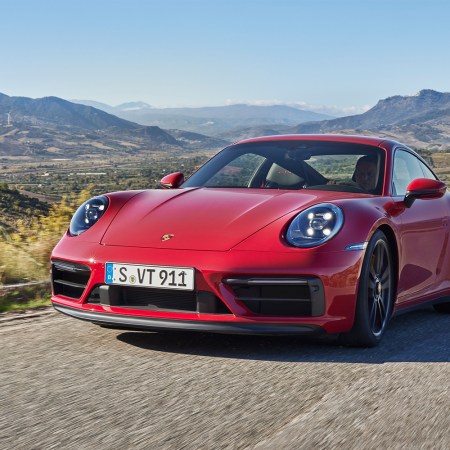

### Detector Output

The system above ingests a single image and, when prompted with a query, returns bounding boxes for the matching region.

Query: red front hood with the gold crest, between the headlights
[102,188,342,251]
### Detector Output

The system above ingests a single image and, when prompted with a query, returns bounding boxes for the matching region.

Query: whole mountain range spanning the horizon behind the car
[0,89,450,157]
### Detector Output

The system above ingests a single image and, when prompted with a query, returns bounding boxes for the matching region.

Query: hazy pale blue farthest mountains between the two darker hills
[70,100,331,136]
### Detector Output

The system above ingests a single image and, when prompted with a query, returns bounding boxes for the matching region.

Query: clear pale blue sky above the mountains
[0,0,450,113]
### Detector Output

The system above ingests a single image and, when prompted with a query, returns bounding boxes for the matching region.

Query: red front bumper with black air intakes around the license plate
[52,239,363,334]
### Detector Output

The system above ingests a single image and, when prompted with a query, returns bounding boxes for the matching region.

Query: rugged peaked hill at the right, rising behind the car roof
[288,89,450,148]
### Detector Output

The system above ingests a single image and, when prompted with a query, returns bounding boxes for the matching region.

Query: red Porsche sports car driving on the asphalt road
[51,135,450,346]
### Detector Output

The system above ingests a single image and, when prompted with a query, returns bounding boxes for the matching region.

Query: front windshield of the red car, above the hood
[183,140,385,195]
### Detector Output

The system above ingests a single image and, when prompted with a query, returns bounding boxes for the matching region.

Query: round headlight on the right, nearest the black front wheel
[286,203,344,247]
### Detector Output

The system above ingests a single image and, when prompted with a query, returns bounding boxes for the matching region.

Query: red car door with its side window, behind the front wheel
[392,149,450,303]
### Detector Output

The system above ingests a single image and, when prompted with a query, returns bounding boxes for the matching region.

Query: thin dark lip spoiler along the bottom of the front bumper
[53,303,324,335]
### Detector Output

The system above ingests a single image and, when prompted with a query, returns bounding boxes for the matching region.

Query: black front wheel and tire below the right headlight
[341,230,394,347]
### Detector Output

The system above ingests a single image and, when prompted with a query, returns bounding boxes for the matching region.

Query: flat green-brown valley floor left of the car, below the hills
[0,147,213,201]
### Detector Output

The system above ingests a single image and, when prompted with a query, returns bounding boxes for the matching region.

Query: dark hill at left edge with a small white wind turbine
[0,93,226,157]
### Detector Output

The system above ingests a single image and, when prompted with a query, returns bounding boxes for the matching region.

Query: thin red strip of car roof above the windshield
[235,134,396,147]
